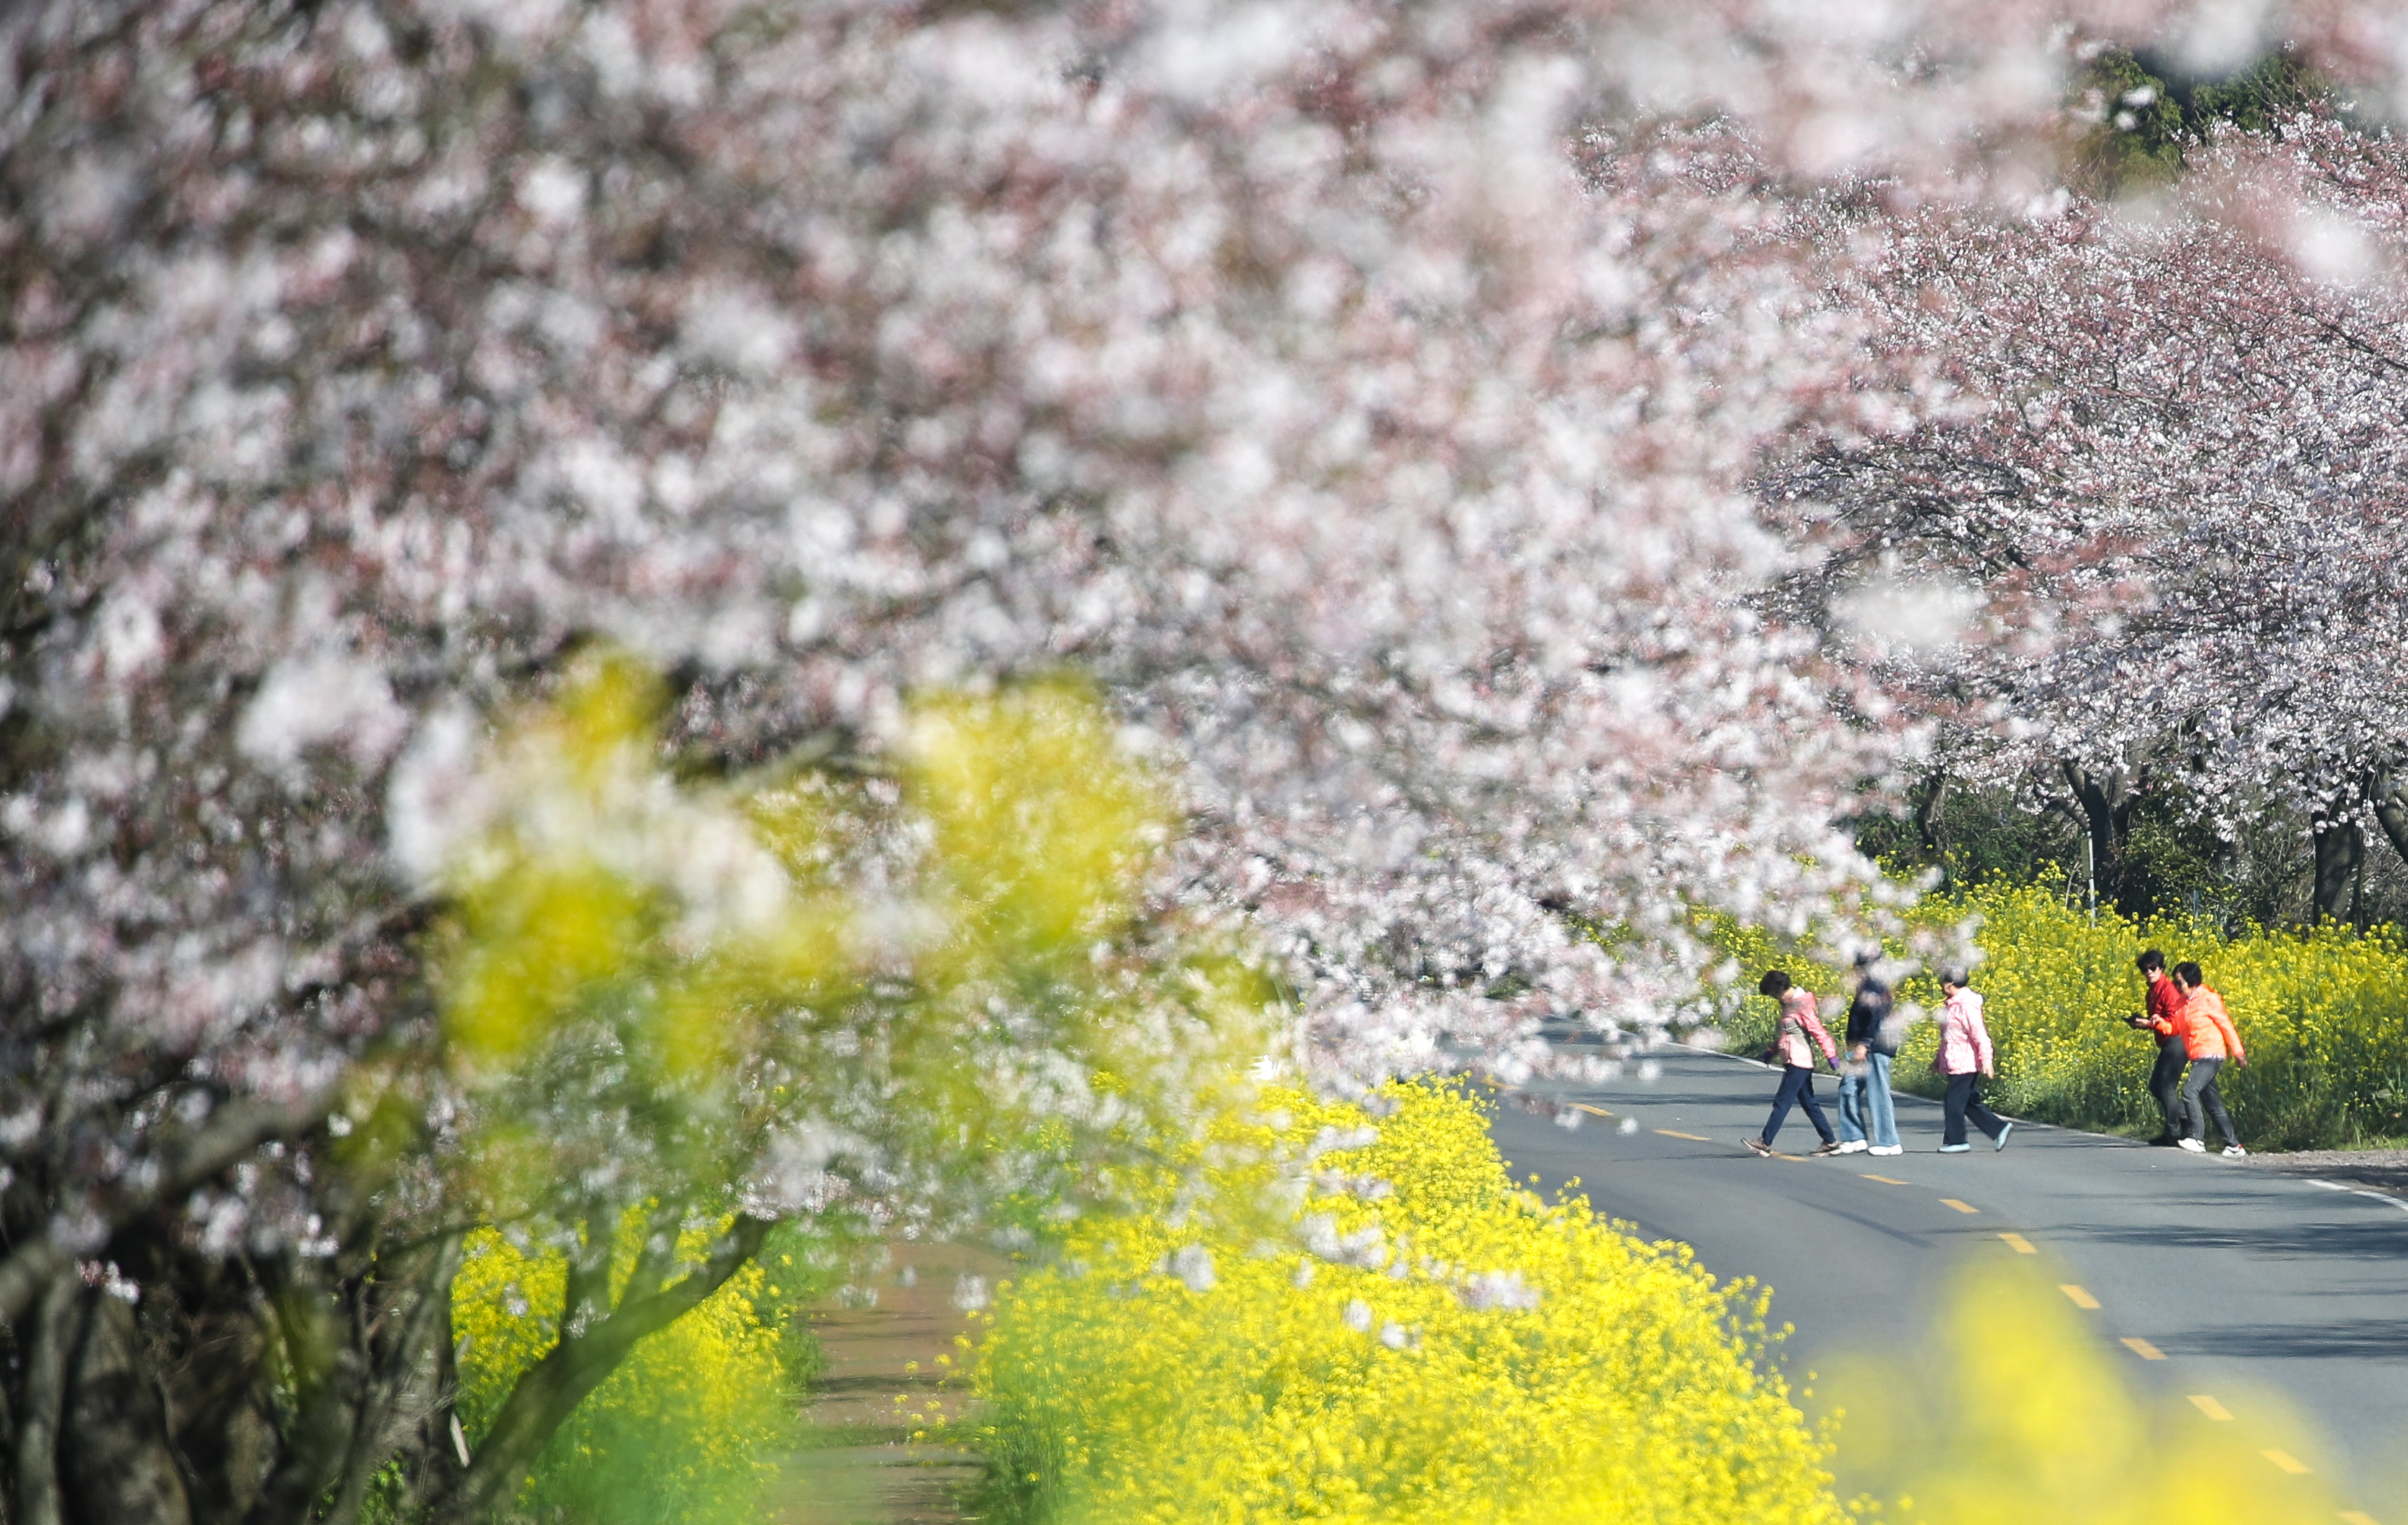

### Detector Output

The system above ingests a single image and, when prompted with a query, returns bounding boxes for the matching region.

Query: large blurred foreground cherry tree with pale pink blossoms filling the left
[0,0,2391,1525]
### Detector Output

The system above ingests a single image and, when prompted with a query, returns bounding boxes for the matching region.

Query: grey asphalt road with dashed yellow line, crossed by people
[1493,1051,2408,1525]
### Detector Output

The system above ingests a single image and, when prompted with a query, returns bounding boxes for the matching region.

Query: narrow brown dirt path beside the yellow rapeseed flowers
[768,1245,1009,1525]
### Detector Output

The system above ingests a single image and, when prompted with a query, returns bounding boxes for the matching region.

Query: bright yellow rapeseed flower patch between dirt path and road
[948,1084,1842,1525]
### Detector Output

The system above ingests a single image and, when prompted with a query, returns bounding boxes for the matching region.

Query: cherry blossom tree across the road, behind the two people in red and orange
[1773,114,2408,913]
